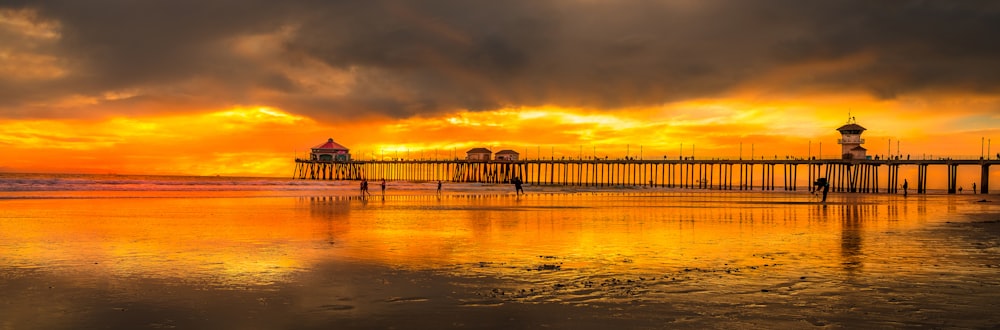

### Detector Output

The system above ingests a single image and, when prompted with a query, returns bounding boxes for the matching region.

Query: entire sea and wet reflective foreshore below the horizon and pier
[0,173,1000,329]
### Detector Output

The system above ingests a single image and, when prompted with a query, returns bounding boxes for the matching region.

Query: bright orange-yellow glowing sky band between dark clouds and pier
[0,96,1000,176]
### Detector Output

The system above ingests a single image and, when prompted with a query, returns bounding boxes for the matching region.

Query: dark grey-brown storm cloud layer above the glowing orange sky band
[0,0,1000,116]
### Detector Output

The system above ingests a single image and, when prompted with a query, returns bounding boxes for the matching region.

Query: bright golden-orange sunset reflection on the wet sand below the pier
[0,192,992,287]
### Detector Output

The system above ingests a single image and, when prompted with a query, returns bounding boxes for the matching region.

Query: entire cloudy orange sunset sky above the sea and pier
[0,0,1000,176]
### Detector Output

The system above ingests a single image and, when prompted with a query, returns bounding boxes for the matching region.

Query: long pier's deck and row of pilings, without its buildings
[293,159,1000,194]
